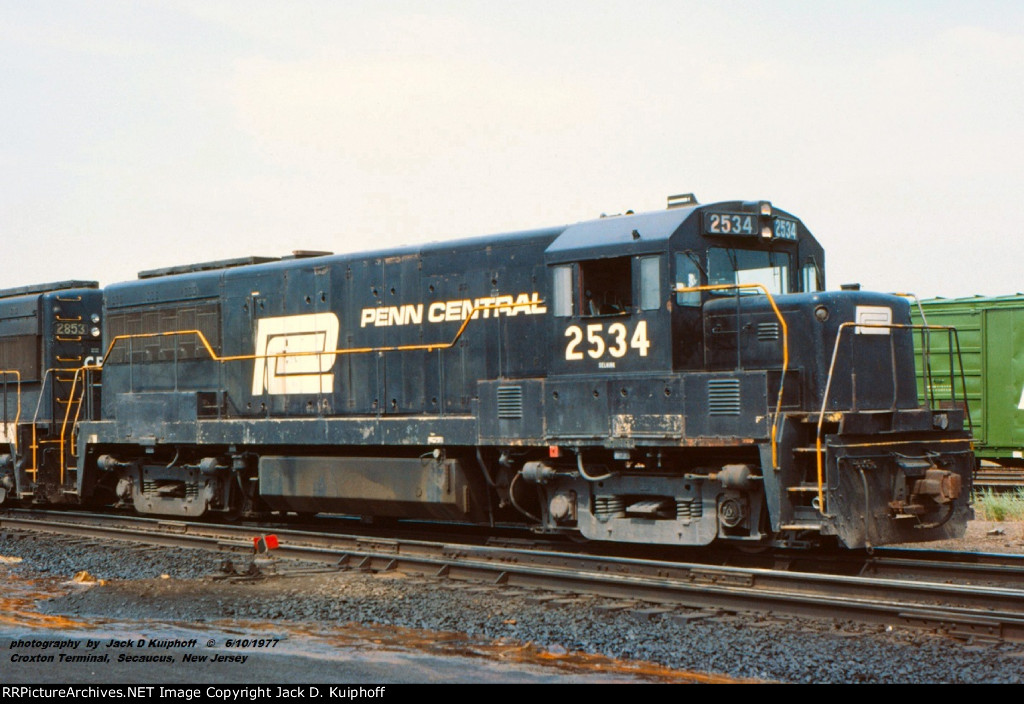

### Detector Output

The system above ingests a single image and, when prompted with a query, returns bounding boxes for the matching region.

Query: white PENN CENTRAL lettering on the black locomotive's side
[359,292,548,327]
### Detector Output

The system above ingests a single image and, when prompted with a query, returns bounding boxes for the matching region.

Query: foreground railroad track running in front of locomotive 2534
[6,511,1024,642]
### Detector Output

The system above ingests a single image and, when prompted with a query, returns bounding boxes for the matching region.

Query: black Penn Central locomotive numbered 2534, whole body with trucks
[12,199,973,547]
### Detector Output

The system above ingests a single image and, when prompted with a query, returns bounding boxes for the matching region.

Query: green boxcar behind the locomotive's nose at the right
[912,294,1024,467]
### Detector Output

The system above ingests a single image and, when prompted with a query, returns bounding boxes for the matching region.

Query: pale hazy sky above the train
[0,0,1024,298]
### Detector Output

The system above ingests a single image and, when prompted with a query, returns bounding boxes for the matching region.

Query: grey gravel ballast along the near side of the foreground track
[0,521,1024,684]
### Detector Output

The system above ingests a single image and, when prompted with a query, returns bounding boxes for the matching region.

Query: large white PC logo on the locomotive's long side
[253,313,340,396]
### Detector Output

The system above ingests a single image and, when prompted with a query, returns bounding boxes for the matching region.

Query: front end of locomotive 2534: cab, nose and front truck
[525,202,972,547]
